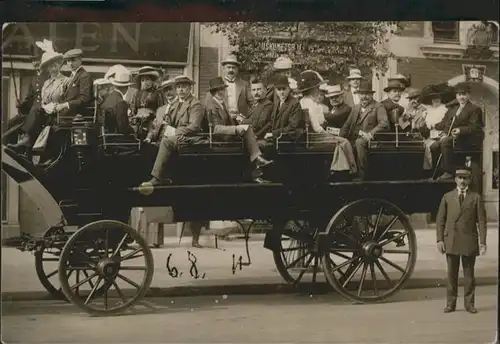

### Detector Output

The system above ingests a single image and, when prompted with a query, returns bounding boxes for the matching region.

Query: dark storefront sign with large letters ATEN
[2,22,191,64]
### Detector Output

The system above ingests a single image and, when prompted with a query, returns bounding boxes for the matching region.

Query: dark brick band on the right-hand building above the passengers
[398,58,498,88]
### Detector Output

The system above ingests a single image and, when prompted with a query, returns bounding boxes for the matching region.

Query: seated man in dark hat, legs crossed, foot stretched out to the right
[206,77,272,183]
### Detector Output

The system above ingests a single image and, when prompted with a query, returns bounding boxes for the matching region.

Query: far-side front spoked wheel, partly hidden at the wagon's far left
[35,228,111,301]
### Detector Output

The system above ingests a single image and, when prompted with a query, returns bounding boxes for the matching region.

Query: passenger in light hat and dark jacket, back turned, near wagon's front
[99,71,133,134]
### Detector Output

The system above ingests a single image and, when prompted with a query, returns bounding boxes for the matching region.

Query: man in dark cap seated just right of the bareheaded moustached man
[261,75,304,145]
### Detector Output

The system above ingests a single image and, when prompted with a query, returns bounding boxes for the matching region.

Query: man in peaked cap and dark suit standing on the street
[436,168,486,313]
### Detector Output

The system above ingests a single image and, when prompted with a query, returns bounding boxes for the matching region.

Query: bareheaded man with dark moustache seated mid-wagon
[241,78,273,139]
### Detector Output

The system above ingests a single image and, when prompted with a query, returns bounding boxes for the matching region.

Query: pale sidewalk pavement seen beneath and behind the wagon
[2,228,498,300]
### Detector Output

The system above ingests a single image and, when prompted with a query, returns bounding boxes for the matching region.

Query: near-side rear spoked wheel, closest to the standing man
[321,199,417,303]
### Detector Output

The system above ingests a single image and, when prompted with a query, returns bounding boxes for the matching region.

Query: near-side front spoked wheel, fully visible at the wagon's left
[59,220,154,316]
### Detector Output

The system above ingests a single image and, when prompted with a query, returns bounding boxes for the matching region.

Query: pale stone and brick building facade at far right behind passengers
[378,21,499,222]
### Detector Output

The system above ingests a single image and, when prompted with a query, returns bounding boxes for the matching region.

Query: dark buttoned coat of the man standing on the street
[436,189,486,256]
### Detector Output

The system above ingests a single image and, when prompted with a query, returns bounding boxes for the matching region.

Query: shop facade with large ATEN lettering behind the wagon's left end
[1,22,229,237]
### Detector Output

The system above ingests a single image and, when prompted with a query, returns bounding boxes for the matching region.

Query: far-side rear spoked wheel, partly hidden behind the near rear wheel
[273,220,317,284]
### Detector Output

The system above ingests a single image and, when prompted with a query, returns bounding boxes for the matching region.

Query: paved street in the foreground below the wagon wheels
[2,286,497,344]
